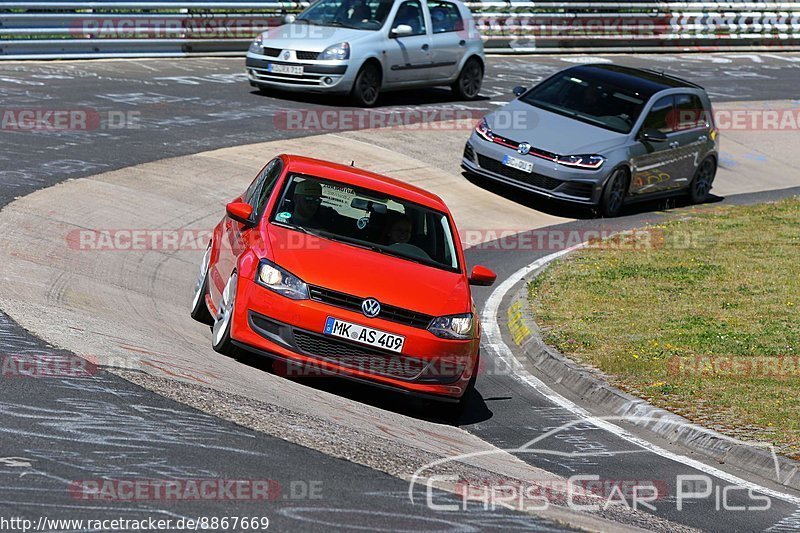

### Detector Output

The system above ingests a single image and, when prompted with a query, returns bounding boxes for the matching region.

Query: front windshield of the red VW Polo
[272,175,460,272]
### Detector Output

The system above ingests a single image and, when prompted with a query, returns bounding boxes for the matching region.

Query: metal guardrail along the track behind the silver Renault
[0,0,800,59]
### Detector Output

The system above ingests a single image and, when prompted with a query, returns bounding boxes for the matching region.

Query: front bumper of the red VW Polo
[231,278,479,400]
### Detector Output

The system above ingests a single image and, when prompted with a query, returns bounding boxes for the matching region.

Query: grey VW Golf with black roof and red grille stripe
[461,64,719,216]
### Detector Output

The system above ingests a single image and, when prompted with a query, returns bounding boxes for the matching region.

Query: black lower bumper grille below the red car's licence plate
[294,329,426,380]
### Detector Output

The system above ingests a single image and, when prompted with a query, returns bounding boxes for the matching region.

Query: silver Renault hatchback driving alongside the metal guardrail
[246,0,484,107]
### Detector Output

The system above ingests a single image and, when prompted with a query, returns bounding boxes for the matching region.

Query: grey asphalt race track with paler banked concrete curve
[0,54,800,531]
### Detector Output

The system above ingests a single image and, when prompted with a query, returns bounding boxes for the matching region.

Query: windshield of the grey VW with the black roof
[520,73,647,133]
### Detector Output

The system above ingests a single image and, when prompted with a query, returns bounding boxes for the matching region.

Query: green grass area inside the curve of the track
[529,197,800,458]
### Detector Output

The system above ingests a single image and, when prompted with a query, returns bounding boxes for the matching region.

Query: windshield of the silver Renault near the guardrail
[297,0,393,30]
